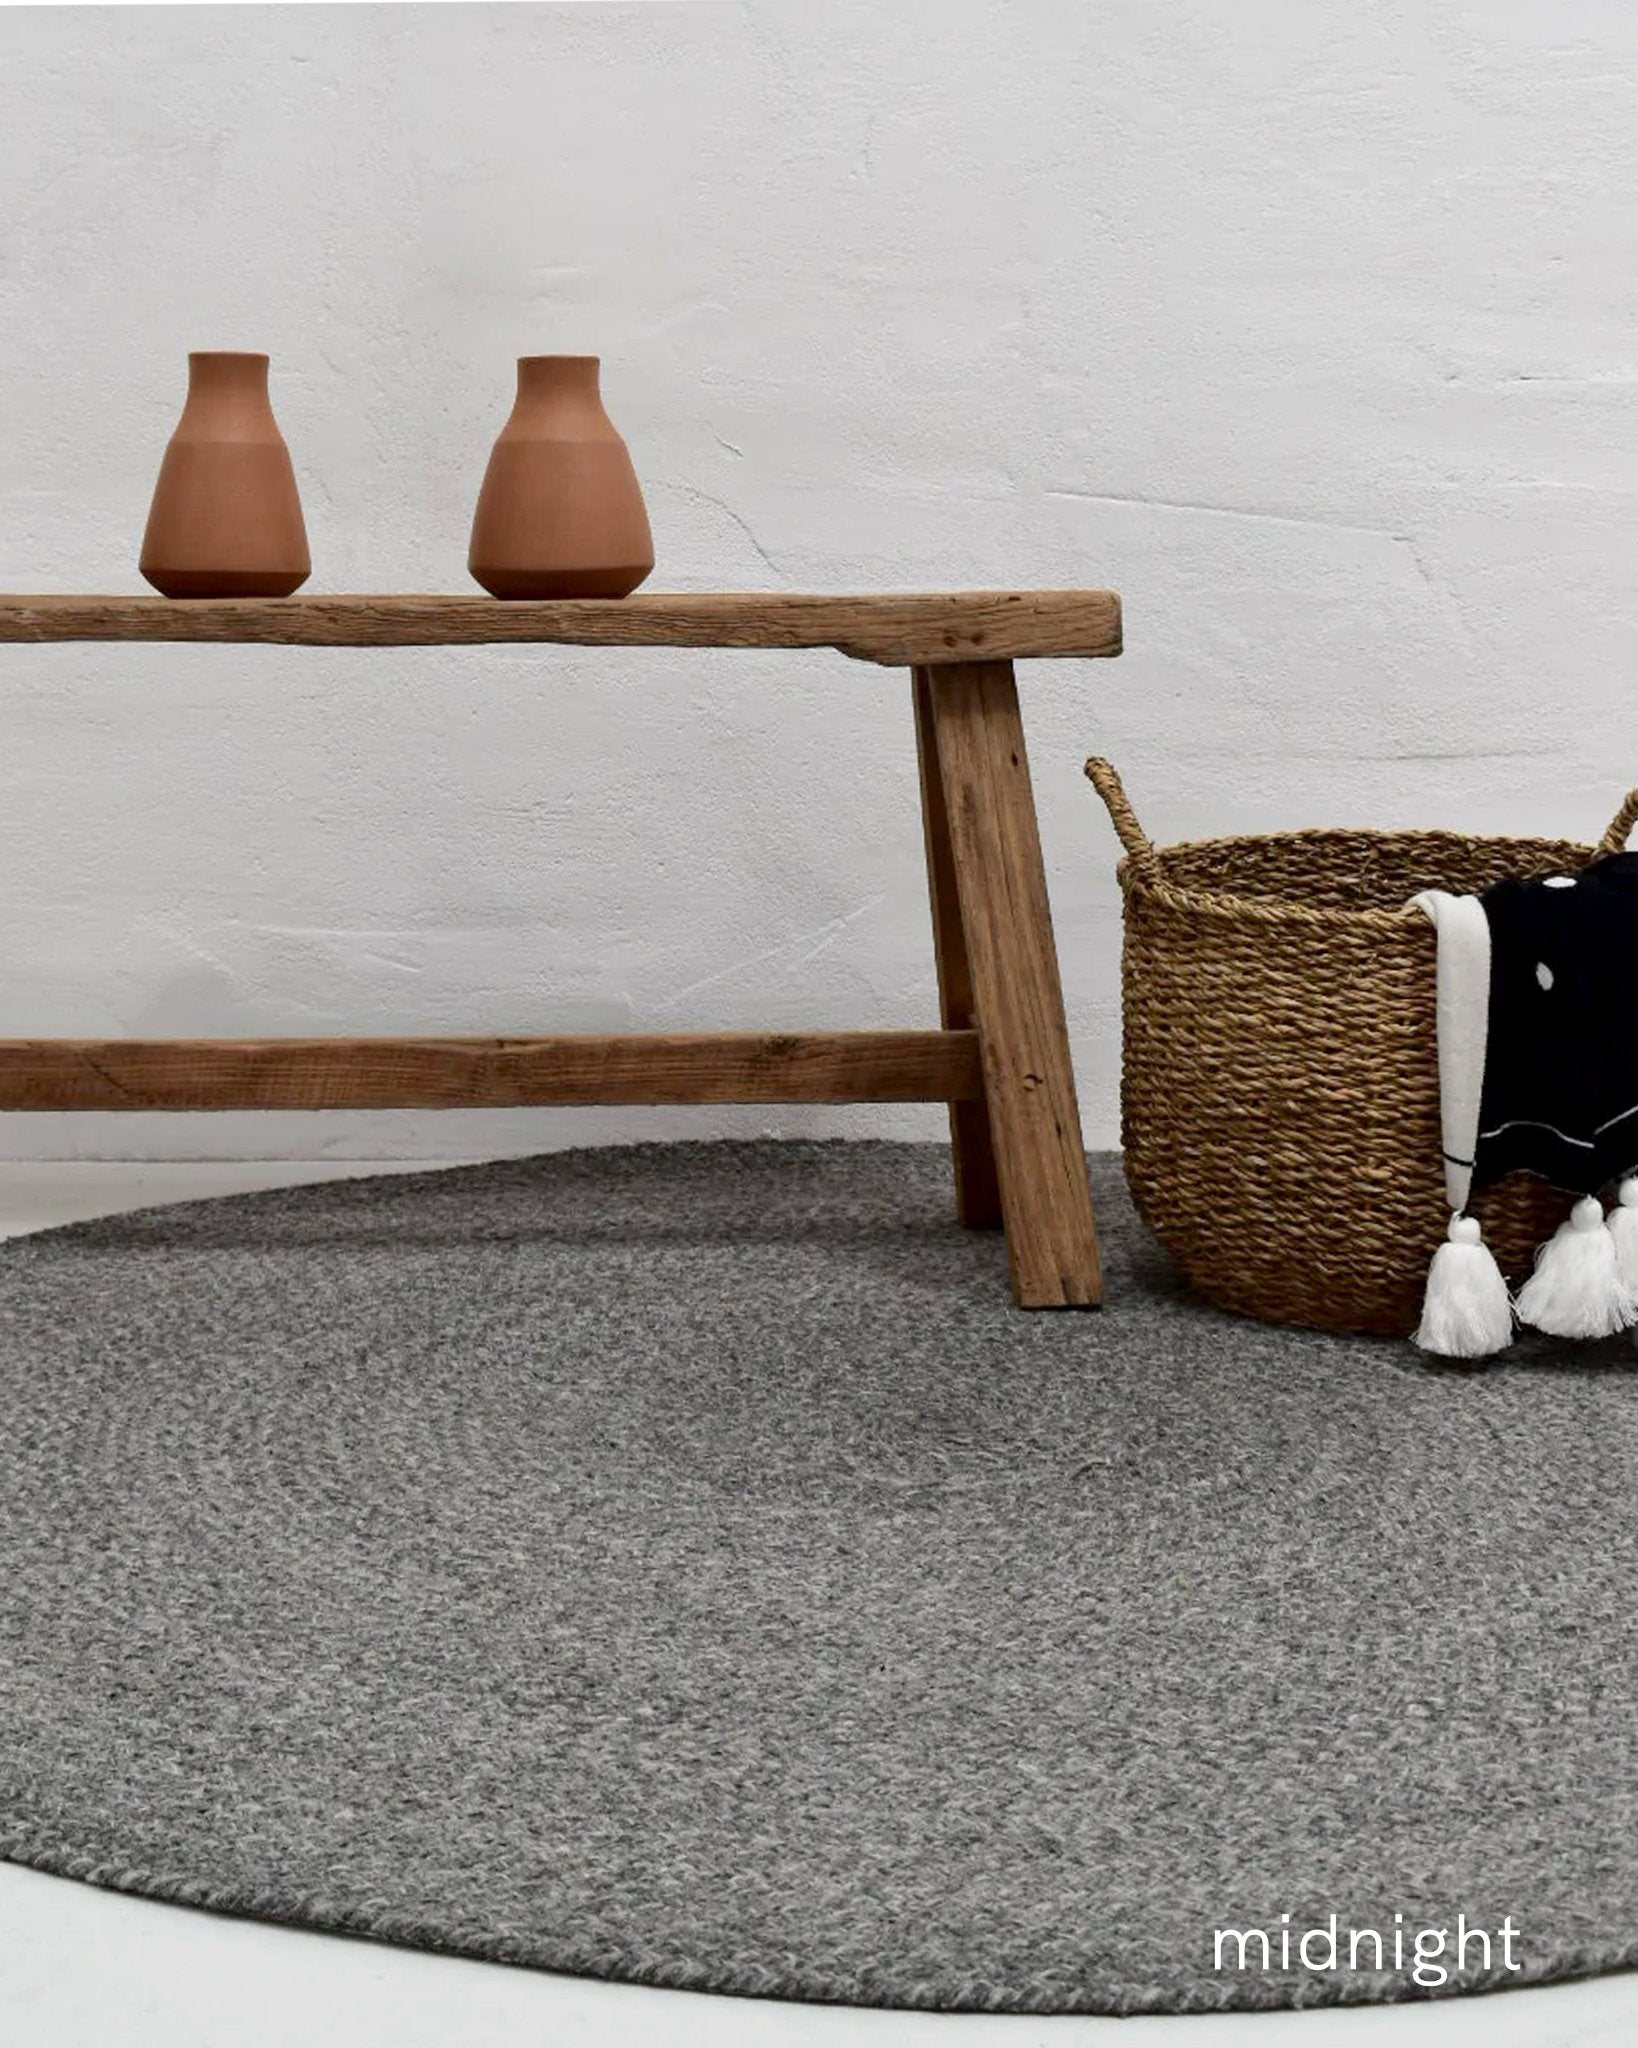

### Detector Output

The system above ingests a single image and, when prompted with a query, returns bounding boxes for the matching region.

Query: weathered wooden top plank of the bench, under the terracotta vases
[0,590,1120,668]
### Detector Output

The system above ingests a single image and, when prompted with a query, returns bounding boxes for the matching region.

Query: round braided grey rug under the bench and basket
[0,1145,1638,2011]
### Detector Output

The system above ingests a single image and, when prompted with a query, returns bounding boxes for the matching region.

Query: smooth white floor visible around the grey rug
[0,1163,1638,2048]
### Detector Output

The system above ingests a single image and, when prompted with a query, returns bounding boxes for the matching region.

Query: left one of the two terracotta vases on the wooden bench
[141,352,313,598]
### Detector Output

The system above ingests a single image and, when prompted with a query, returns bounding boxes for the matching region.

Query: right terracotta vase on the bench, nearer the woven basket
[467,356,653,598]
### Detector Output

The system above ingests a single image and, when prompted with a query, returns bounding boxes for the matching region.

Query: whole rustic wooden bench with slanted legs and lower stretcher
[0,590,1120,1309]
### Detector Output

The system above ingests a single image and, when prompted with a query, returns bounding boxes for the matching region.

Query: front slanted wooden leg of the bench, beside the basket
[915,662,1104,1309]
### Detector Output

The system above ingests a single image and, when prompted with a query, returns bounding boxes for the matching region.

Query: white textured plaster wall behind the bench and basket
[0,0,1638,1155]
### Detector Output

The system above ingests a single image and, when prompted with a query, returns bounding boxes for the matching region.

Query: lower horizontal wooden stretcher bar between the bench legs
[0,1030,981,1110]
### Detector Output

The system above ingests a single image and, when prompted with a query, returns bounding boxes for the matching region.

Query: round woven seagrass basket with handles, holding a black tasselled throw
[1087,760,1638,1337]
